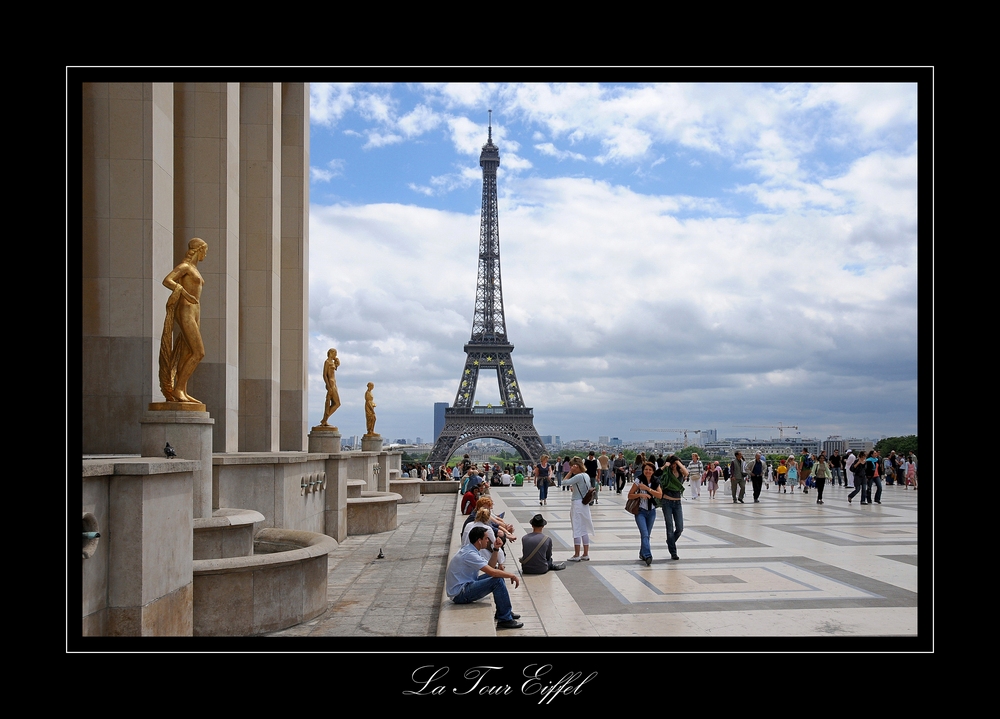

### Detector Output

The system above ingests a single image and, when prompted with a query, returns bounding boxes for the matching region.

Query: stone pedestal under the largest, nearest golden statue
[140,410,215,519]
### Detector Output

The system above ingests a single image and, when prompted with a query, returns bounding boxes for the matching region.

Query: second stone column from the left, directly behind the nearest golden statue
[174,82,240,452]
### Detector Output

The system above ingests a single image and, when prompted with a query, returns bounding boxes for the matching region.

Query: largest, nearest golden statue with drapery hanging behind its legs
[151,237,208,409]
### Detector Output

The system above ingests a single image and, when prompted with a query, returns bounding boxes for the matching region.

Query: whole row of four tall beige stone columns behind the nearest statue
[82,83,309,454]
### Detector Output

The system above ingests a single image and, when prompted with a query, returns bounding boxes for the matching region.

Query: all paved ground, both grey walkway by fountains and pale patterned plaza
[271,484,926,638]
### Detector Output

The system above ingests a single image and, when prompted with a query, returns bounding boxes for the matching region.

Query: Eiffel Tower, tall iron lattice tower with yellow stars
[427,110,545,463]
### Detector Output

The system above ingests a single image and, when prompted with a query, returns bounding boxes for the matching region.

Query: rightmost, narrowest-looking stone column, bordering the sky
[280,82,309,452]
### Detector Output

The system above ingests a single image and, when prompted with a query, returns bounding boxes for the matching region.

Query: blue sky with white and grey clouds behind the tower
[310,83,917,448]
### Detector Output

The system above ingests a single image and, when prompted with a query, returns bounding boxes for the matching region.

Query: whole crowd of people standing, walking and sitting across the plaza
[450,450,917,629]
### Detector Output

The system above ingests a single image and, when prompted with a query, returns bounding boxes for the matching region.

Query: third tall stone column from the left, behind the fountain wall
[239,82,281,452]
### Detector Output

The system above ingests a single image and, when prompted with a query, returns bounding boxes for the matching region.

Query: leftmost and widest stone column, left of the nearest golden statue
[81,83,174,454]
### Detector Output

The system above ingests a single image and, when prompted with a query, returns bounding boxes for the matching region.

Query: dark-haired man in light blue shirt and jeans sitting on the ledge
[445,527,524,629]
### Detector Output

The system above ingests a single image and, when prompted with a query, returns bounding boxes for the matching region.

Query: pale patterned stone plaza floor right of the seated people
[494,478,919,637]
